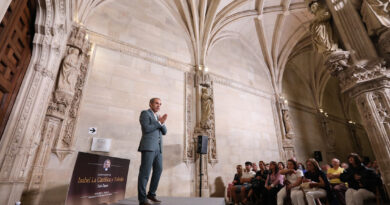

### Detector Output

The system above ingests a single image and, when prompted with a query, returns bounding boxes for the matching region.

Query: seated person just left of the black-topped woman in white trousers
[277,159,303,205]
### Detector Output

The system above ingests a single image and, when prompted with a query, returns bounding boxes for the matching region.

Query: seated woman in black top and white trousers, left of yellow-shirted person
[291,158,330,205]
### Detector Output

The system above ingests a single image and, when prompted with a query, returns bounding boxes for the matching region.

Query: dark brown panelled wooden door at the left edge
[0,0,35,139]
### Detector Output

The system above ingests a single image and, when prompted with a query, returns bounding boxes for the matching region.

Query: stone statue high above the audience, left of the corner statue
[309,1,338,55]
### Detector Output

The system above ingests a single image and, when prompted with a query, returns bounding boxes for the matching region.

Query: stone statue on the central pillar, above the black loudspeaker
[200,87,213,130]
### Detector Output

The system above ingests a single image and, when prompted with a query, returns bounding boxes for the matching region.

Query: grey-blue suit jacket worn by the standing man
[138,109,167,153]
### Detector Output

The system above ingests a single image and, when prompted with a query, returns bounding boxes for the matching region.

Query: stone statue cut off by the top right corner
[360,0,390,36]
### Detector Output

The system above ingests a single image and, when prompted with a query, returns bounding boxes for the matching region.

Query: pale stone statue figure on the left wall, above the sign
[57,47,79,94]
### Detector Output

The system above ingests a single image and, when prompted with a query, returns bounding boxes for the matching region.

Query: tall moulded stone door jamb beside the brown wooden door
[0,0,70,204]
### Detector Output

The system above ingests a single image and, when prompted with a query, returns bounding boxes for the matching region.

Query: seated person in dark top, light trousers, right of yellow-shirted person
[340,153,381,205]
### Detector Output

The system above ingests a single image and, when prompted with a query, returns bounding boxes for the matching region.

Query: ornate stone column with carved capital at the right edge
[347,64,390,194]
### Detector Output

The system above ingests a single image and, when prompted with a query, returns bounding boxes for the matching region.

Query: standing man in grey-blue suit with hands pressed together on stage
[138,98,168,205]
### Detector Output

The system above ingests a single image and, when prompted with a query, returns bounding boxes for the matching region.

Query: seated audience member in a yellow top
[327,158,347,205]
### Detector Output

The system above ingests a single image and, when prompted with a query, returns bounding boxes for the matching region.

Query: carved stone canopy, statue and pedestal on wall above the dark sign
[47,26,90,160]
